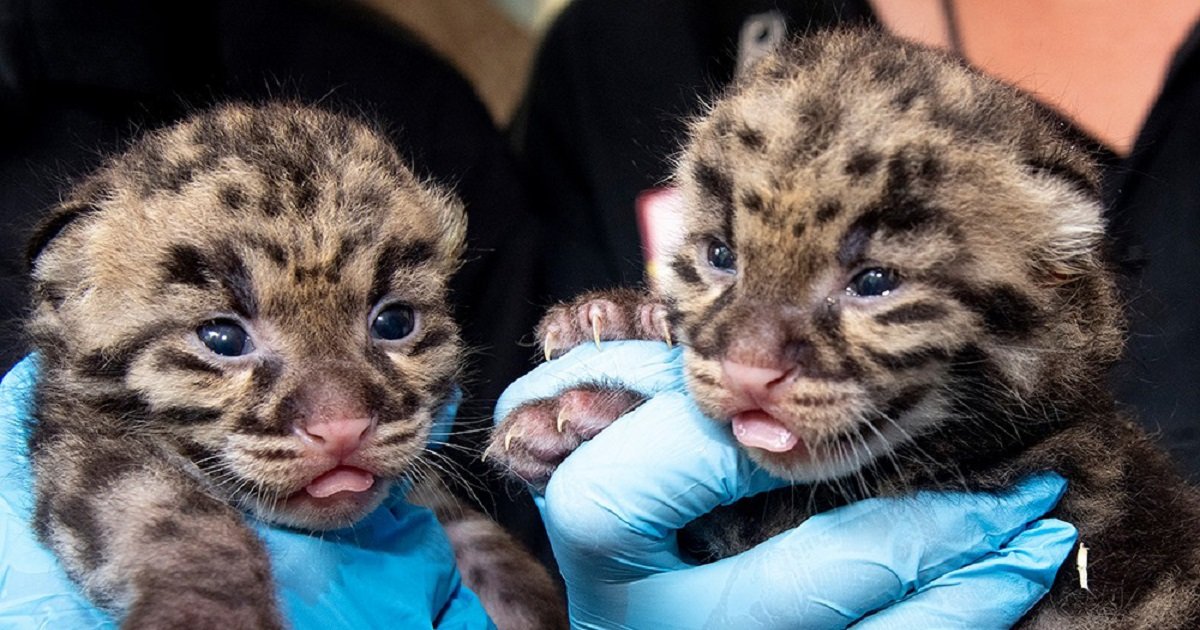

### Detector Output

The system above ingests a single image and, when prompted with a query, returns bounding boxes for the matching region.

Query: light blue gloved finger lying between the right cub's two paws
[494,341,684,422]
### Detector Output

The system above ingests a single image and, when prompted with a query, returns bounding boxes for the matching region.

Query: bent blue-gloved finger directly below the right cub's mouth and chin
[539,391,787,580]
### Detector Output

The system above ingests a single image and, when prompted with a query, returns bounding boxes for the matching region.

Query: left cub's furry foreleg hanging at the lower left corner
[30,432,283,629]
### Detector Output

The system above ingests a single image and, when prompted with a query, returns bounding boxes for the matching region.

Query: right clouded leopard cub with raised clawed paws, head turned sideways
[490,31,1200,629]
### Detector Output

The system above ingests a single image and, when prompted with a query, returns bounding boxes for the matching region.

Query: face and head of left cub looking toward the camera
[32,106,464,529]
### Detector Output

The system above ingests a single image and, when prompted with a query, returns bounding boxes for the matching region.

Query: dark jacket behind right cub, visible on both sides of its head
[515,0,1200,481]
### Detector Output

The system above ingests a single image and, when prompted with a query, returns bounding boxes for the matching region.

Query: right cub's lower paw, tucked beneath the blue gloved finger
[484,385,646,490]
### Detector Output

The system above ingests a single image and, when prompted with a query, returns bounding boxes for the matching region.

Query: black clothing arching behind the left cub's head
[0,0,540,544]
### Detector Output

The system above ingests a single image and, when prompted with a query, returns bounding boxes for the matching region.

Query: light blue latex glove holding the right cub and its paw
[496,342,1075,629]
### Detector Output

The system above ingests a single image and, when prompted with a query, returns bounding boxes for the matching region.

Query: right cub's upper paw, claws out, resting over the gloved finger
[536,289,671,361]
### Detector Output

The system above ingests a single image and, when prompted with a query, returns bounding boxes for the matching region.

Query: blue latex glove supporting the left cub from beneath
[0,359,494,630]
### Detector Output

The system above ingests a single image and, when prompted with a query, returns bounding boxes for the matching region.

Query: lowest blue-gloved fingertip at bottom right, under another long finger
[854,518,1078,630]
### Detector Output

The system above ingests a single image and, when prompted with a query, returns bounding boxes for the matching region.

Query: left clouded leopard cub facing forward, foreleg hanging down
[29,104,565,629]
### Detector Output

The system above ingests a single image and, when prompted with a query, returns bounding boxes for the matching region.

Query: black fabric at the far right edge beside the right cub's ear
[1108,24,1200,482]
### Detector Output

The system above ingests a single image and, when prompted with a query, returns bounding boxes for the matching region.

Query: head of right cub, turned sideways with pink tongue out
[660,34,1120,481]
